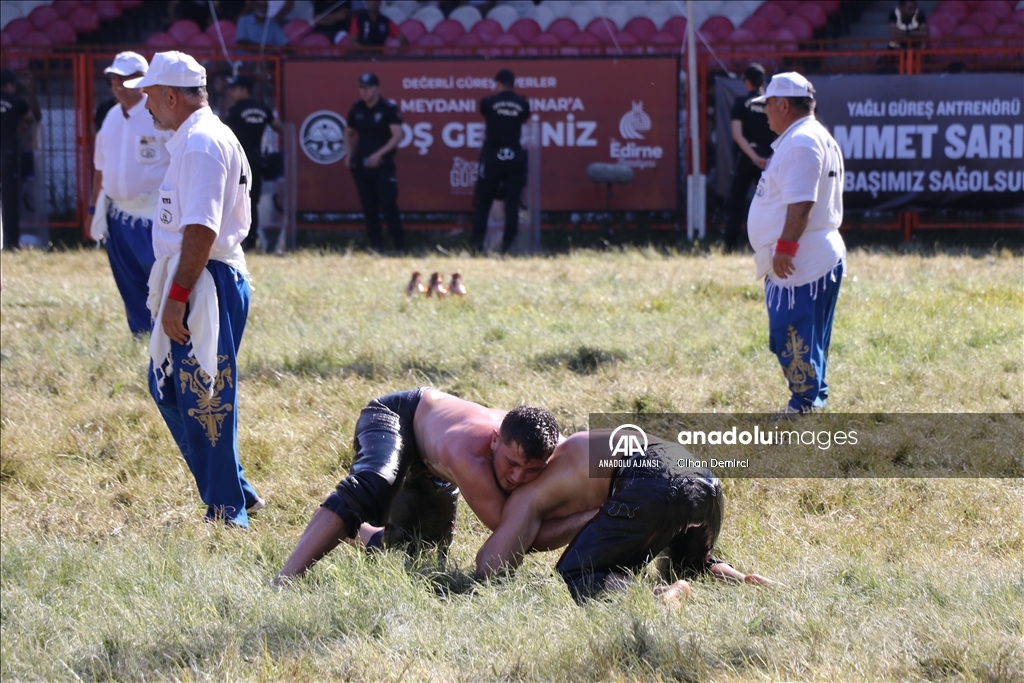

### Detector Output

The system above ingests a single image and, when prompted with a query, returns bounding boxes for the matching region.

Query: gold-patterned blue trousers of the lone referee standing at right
[765,263,843,413]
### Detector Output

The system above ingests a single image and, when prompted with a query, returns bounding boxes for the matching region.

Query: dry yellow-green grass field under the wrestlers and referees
[0,246,1024,683]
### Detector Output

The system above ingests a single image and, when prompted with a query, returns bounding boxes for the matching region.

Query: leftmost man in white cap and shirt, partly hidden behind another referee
[87,52,171,336]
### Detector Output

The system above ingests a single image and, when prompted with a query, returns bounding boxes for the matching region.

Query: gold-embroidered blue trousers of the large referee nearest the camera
[150,260,258,528]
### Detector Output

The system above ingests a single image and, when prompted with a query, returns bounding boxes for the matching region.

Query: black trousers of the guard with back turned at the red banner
[473,147,526,252]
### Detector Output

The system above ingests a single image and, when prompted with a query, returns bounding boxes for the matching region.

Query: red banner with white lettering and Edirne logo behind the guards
[284,57,679,213]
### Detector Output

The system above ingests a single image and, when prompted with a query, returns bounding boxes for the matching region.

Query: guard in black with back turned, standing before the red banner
[473,69,529,253]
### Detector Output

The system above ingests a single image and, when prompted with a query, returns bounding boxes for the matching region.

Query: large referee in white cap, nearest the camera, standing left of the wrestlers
[125,52,263,527]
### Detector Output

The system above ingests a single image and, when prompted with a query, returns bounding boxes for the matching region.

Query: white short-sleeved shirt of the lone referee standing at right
[746,115,846,287]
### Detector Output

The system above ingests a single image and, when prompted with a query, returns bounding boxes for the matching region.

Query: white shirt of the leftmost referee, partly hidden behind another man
[93,95,171,205]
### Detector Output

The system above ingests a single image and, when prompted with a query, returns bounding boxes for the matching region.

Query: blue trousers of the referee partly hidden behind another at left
[106,205,157,335]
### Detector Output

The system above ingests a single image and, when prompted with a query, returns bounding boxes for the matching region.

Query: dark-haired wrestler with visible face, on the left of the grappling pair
[274,387,561,584]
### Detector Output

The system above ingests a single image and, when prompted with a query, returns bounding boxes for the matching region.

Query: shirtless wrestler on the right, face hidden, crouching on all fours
[476,430,774,604]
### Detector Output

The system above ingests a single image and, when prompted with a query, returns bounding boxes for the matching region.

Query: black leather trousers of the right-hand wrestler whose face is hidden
[556,443,725,603]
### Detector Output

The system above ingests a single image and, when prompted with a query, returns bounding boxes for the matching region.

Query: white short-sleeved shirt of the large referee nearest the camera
[153,106,252,272]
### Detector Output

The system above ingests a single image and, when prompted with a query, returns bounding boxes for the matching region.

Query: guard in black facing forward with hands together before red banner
[345,74,406,252]
